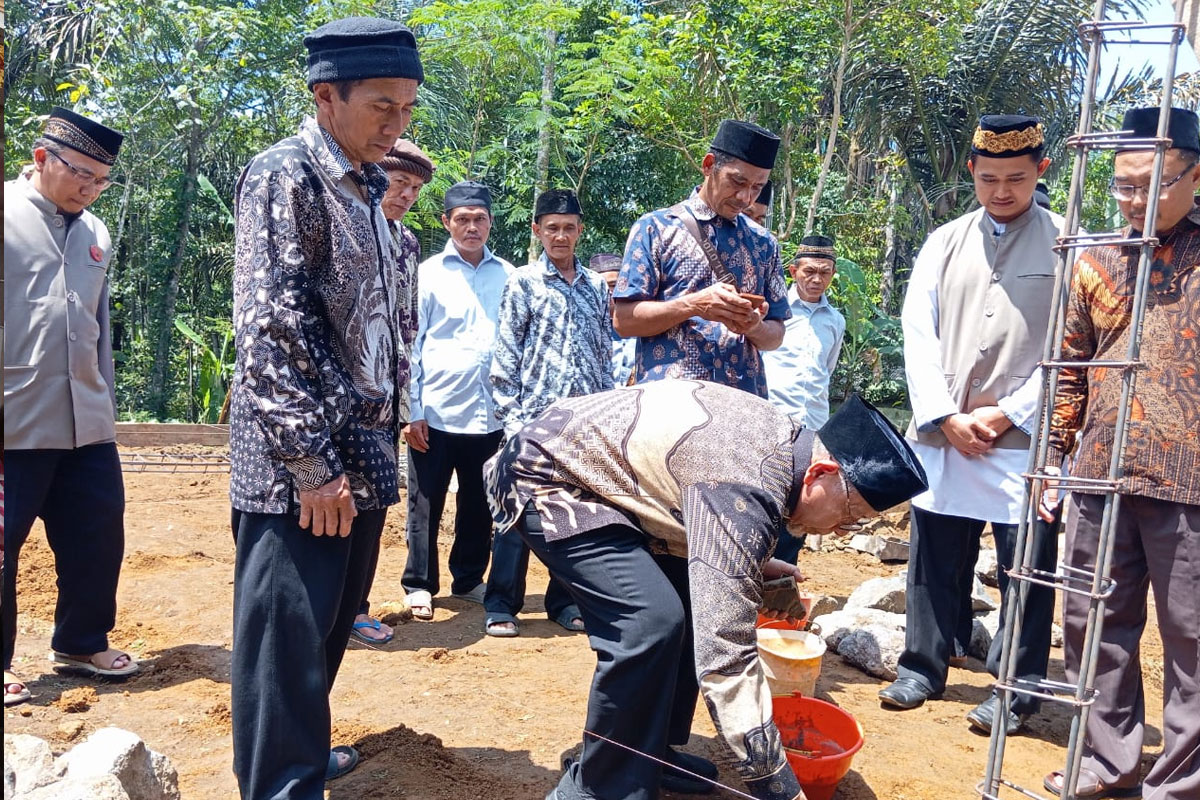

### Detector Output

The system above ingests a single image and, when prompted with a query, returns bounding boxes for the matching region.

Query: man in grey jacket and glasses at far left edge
[2,108,138,705]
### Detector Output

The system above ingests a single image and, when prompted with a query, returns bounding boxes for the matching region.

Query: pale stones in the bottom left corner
[4,728,179,800]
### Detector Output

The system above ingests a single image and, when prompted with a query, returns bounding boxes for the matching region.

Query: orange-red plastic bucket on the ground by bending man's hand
[772,694,863,800]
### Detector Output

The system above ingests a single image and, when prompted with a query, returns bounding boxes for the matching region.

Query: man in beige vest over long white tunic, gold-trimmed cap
[880,114,1063,734]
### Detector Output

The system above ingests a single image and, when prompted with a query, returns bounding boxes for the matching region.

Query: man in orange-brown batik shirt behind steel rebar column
[1040,107,1200,800]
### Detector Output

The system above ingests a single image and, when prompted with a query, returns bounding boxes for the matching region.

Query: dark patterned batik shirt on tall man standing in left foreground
[229,119,403,513]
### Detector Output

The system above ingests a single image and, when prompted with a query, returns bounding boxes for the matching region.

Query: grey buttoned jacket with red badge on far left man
[4,176,116,450]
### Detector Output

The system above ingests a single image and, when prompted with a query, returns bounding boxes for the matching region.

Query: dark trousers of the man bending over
[520,511,696,800]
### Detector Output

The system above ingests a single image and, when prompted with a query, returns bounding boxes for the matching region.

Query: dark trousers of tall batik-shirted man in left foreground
[230,510,388,800]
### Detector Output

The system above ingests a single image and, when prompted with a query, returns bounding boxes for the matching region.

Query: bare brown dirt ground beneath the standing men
[5,460,1162,800]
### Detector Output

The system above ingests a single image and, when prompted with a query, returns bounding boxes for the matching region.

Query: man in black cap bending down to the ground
[485,378,925,800]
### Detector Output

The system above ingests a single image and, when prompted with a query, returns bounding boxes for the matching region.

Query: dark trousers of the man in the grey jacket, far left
[2,443,125,669]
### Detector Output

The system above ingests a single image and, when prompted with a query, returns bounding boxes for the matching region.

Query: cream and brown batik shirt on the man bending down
[484,380,800,800]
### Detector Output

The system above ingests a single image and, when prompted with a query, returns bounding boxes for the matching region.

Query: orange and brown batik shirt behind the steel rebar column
[1050,200,1200,505]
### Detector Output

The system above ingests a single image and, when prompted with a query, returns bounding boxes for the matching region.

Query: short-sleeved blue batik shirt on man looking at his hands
[613,191,792,397]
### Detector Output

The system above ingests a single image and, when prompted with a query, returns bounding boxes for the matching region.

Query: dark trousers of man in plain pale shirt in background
[401,428,504,595]
